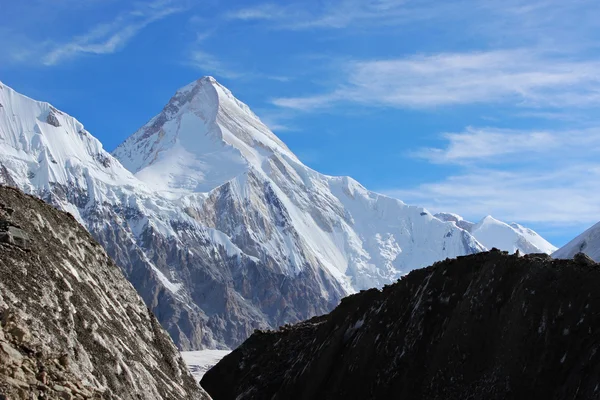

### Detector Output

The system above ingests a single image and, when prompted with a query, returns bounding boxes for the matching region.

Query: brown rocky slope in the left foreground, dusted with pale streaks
[0,187,208,400]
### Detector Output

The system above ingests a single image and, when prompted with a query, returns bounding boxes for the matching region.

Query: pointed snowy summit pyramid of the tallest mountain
[113,77,299,197]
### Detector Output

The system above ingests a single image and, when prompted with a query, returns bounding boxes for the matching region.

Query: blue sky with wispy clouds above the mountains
[0,0,600,245]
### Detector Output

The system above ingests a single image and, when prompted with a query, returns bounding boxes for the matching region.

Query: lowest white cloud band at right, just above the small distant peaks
[382,163,600,230]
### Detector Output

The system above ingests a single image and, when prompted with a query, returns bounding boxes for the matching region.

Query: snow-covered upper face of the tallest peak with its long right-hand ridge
[113,77,482,296]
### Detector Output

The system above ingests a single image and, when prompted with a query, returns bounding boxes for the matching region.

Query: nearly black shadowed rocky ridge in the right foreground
[202,251,600,400]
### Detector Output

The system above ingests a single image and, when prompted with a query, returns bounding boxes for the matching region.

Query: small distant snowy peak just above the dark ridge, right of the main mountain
[435,213,556,254]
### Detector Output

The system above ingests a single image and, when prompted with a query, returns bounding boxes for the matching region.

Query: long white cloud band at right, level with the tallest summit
[273,49,600,111]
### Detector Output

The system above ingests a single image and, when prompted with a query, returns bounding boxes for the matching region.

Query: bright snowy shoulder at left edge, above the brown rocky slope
[0,80,144,200]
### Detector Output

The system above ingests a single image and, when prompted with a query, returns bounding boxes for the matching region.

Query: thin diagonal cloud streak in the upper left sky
[42,0,184,66]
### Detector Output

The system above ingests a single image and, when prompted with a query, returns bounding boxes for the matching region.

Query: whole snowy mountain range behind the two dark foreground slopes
[0,77,553,349]
